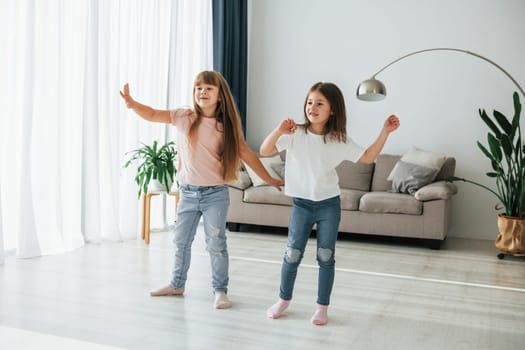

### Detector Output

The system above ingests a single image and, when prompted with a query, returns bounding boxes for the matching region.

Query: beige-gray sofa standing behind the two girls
[227,154,457,249]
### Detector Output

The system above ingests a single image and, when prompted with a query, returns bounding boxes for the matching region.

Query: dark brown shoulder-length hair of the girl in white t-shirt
[303,82,346,143]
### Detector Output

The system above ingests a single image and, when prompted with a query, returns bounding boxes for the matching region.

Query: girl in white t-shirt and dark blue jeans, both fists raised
[260,82,399,325]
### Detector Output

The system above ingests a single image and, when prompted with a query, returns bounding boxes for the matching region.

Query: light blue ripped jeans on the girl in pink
[170,185,230,292]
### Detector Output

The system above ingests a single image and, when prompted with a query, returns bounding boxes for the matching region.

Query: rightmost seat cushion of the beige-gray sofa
[359,192,423,215]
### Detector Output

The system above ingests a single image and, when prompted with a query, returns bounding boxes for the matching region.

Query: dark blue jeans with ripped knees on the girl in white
[279,196,341,305]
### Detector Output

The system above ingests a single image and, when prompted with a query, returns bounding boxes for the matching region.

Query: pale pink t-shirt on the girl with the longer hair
[170,108,225,186]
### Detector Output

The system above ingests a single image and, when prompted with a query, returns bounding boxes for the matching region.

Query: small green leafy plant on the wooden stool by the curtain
[124,140,177,198]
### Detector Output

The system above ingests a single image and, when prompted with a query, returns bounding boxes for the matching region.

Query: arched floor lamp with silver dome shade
[357,47,525,101]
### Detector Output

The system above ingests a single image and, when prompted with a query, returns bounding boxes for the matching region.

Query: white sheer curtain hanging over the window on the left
[0,0,212,257]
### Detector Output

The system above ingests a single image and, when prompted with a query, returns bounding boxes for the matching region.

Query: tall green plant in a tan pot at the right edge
[450,92,525,259]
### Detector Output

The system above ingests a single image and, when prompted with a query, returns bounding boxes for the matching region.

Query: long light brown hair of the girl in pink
[188,71,244,181]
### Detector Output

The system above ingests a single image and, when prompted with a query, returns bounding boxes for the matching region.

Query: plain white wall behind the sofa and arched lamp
[247,0,525,239]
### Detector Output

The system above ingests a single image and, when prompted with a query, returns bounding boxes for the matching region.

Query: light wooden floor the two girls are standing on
[0,224,525,350]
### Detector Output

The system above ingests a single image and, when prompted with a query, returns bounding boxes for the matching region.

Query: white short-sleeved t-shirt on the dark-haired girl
[276,128,365,201]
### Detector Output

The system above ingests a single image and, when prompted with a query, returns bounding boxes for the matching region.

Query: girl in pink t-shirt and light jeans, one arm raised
[120,71,283,309]
